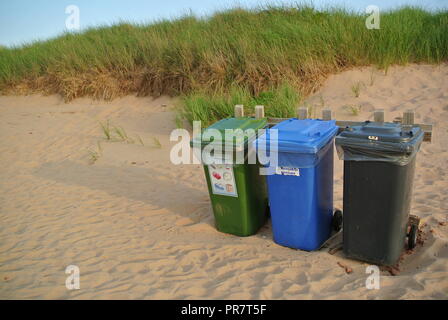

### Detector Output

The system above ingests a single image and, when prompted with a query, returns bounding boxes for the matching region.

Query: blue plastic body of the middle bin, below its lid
[267,139,334,251]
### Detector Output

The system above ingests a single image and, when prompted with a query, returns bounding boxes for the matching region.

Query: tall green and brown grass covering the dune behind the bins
[0,6,448,120]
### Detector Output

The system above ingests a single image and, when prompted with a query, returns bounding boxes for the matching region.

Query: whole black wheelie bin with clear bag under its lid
[335,121,423,265]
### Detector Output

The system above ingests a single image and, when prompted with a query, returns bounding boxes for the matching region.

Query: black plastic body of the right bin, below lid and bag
[343,157,416,265]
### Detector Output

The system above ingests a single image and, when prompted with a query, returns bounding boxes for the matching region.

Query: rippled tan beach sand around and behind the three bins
[0,64,448,299]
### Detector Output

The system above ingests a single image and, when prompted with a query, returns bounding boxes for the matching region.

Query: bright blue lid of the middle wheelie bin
[257,118,339,153]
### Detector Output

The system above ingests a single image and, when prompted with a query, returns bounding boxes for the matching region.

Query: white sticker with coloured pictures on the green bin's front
[208,164,238,197]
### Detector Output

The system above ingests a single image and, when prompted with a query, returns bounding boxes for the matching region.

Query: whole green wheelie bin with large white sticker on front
[191,117,268,237]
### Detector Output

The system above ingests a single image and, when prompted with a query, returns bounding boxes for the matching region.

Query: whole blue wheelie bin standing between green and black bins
[254,118,338,251]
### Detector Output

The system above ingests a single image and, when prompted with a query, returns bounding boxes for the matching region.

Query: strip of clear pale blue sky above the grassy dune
[0,0,448,46]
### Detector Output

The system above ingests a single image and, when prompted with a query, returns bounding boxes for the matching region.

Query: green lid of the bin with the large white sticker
[191,117,267,149]
